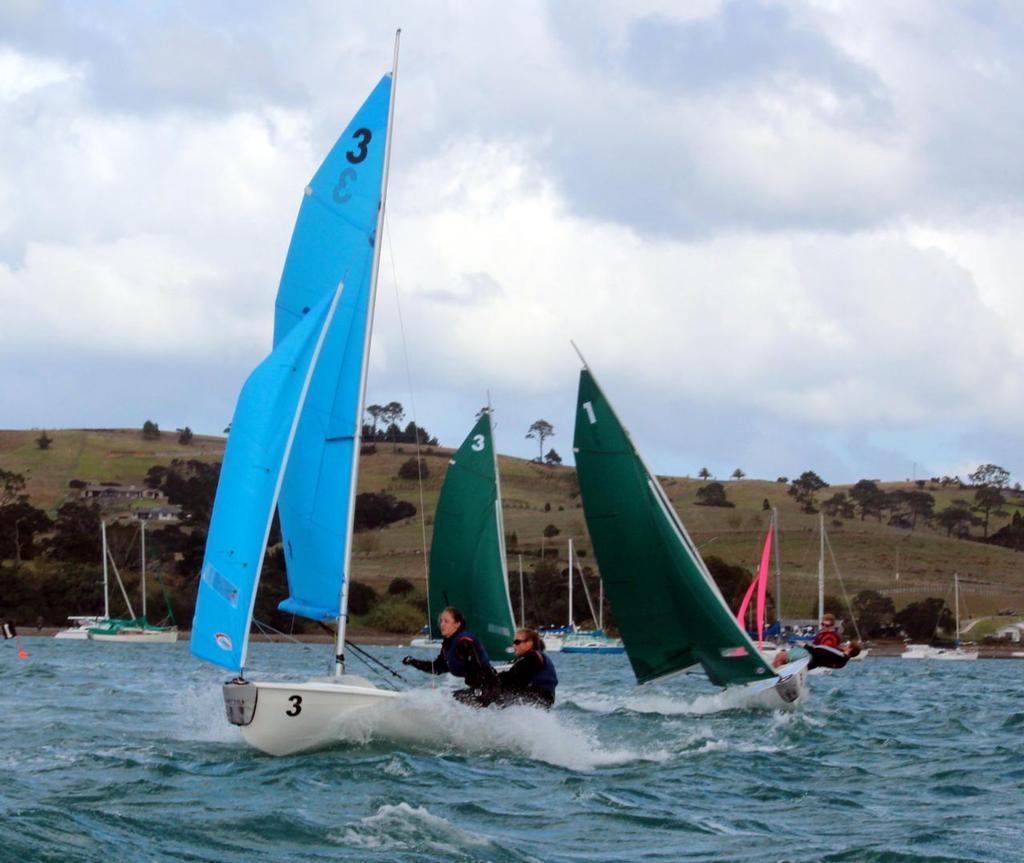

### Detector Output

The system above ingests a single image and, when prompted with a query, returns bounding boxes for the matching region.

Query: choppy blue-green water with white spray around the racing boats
[0,639,1024,863]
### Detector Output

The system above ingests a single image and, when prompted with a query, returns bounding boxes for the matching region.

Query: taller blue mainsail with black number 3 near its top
[274,75,391,620]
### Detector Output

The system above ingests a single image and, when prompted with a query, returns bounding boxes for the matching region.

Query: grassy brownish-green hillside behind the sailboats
[0,429,1024,616]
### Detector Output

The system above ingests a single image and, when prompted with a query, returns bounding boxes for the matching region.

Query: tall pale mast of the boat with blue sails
[334,30,401,677]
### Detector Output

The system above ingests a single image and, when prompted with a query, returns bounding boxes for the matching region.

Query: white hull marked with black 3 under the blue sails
[224,675,401,756]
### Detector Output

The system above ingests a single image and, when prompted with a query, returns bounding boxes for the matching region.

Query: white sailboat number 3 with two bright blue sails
[191,34,398,756]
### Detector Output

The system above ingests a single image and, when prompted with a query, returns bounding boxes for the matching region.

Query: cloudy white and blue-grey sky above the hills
[0,0,1024,482]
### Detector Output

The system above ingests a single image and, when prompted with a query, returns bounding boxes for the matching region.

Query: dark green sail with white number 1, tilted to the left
[573,369,774,686]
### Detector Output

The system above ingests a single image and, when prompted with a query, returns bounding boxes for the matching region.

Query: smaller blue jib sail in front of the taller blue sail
[191,296,337,671]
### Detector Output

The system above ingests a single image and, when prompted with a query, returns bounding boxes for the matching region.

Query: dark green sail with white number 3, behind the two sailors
[429,411,514,659]
